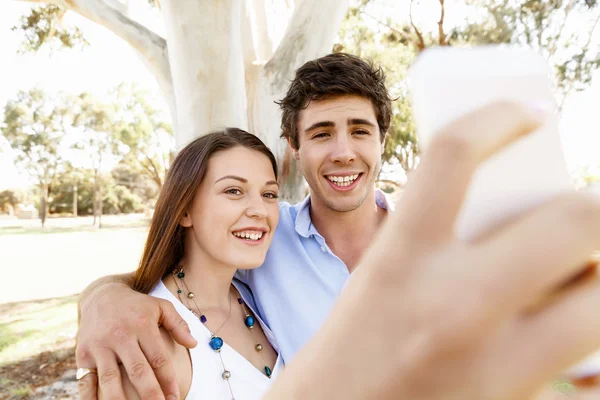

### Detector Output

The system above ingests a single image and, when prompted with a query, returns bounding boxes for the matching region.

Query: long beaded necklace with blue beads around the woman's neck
[172,265,272,400]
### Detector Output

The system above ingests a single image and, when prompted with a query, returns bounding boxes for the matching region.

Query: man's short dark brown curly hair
[277,53,392,150]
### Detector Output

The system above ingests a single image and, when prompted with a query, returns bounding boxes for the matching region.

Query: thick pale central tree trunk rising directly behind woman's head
[161,0,248,149]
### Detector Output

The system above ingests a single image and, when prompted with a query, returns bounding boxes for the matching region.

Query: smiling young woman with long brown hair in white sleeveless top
[99,129,282,400]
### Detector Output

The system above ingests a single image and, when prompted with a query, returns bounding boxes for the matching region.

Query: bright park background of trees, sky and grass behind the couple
[0,0,600,399]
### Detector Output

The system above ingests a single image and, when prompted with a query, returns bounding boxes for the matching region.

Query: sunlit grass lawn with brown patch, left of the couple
[0,216,147,400]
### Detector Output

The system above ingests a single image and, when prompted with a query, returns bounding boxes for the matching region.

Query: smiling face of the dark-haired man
[294,96,382,212]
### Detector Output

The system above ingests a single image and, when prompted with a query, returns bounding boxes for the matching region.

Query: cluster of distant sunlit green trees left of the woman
[0,85,173,226]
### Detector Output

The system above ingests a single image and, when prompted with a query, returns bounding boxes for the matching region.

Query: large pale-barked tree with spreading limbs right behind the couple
[36,0,350,202]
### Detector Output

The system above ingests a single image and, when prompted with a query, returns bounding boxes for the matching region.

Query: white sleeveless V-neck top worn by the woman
[149,280,283,400]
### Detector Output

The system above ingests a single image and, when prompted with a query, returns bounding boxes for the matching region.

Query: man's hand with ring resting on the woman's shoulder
[76,278,197,400]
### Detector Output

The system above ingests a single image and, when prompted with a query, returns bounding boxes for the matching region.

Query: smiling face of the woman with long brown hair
[181,147,279,269]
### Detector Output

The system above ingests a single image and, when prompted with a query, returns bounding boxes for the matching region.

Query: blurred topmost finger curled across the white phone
[397,102,543,242]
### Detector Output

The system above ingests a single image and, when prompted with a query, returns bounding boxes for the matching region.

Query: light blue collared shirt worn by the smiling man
[238,191,389,363]
